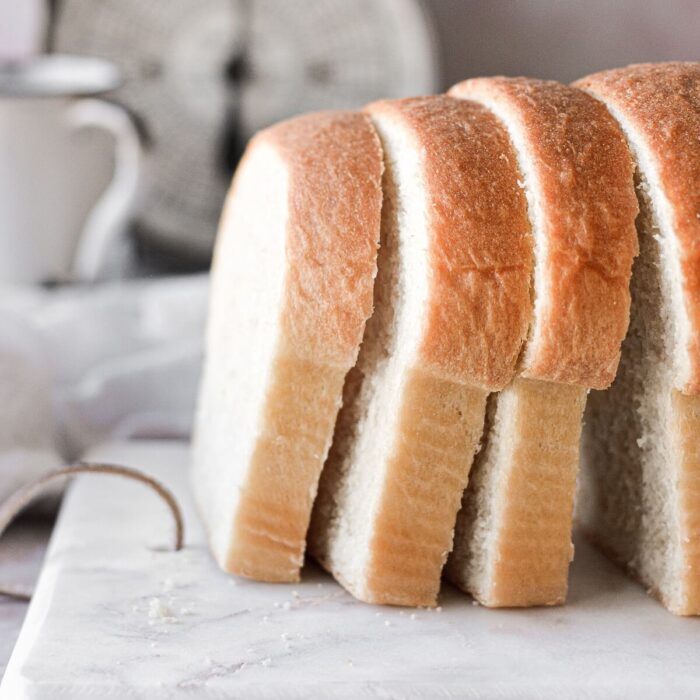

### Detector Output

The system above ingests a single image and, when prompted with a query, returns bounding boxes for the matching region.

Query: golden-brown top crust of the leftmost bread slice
[246,112,383,369]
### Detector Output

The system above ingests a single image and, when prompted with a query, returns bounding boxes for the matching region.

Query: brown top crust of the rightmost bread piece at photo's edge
[576,63,700,395]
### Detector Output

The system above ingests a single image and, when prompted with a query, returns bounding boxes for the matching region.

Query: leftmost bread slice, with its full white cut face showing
[192,112,383,581]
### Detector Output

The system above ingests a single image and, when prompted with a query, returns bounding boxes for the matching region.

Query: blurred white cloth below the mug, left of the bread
[0,275,208,498]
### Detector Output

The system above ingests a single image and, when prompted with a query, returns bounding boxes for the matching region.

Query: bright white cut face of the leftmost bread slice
[192,143,288,567]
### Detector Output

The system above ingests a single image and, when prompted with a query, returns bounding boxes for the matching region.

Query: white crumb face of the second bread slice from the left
[309,112,428,599]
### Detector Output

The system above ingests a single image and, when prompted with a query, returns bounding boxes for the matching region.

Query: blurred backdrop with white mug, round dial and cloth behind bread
[0,0,700,495]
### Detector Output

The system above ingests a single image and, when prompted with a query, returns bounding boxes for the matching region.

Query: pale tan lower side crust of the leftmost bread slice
[220,356,345,582]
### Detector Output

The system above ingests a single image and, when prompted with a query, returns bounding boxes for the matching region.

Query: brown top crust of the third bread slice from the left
[450,77,638,389]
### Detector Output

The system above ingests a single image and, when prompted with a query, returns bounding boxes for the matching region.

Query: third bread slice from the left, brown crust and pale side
[446,78,637,607]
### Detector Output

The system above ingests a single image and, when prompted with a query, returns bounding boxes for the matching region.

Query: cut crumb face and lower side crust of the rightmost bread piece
[577,90,700,614]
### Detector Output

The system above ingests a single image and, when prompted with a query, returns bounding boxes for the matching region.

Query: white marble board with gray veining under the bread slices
[0,442,700,700]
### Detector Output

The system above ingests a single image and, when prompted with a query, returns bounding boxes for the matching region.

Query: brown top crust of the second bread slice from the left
[366,95,532,391]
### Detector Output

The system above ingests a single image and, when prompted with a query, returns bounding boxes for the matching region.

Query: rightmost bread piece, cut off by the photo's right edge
[577,63,700,615]
